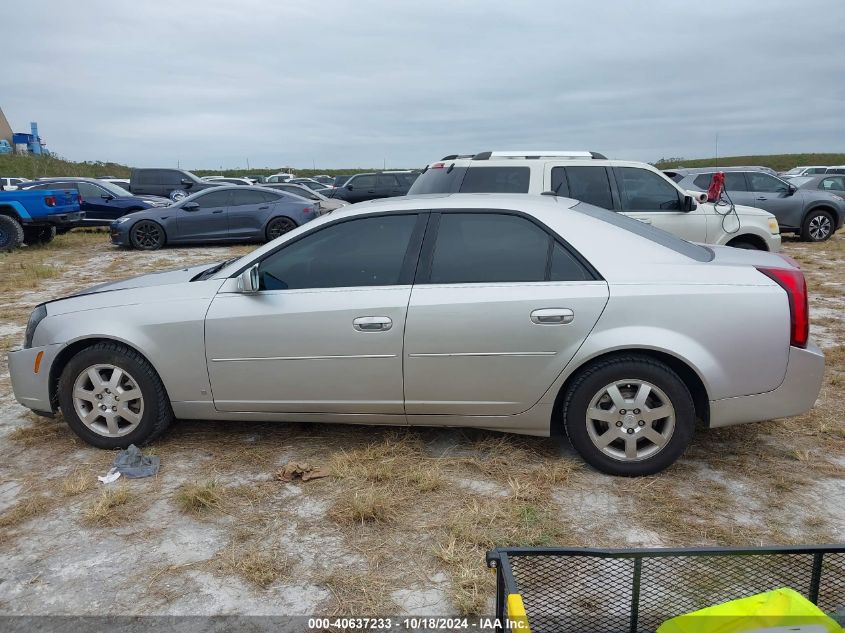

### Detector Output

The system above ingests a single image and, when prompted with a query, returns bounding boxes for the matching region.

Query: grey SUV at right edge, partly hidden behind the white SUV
[666,167,845,242]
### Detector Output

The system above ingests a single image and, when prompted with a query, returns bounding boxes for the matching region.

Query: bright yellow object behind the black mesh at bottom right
[657,588,842,633]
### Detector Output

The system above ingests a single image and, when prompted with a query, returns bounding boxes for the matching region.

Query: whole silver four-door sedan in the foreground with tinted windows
[9,193,824,475]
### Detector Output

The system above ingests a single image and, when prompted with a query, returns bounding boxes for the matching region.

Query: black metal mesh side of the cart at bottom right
[487,545,845,633]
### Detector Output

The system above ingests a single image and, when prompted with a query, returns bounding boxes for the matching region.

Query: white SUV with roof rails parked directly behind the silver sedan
[408,151,780,252]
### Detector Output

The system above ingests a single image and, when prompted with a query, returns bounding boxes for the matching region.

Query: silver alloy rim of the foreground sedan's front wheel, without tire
[73,364,144,437]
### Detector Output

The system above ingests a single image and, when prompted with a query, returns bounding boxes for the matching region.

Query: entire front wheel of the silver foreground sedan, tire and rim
[58,343,173,448]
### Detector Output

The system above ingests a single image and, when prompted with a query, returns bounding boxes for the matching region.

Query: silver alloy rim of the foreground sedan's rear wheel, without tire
[586,379,675,462]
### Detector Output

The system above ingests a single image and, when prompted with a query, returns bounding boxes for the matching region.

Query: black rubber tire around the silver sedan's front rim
[58,342,173,449]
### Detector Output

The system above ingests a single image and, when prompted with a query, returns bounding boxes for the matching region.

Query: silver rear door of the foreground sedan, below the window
[405,281,608,414]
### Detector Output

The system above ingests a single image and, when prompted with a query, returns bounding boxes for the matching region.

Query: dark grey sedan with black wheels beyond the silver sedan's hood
[110,185,320,250]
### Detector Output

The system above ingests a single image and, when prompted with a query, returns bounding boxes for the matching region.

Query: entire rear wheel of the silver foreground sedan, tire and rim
[563,356,695,476]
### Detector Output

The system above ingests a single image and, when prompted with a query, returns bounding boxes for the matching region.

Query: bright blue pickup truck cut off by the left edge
[0,189,85,251]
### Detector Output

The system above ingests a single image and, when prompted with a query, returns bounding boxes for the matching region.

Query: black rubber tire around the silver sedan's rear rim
[562,354,695,477]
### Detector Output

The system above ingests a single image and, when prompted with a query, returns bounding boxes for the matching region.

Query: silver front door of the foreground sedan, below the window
[205,286,411,414]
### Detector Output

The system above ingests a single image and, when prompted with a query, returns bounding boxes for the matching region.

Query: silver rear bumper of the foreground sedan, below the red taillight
[710,341,824,428]
